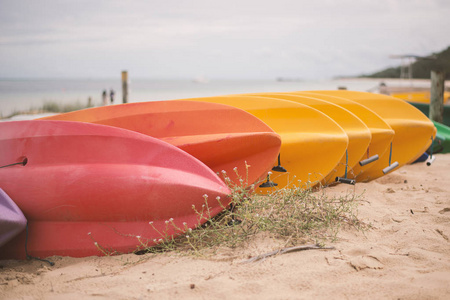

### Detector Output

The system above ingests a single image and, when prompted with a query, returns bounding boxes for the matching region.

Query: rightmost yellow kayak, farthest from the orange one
[306,90,436,178]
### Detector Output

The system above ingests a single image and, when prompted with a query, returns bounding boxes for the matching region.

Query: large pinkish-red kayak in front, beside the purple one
[0,121,230,258]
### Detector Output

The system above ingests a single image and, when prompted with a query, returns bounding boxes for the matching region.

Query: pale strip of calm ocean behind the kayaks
[0,78,429,117]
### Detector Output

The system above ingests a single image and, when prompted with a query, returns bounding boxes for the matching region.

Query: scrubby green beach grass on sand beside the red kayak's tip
[140,170,370,256]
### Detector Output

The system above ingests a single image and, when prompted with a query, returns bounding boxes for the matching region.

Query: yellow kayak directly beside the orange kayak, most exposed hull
[185,95,348,193]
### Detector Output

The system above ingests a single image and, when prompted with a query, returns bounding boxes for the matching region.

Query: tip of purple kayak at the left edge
[0,188,27,247]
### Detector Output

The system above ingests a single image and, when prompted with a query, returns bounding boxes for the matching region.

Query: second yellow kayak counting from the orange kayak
[244,93,372,184]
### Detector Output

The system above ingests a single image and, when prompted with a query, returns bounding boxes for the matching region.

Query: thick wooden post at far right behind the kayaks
[429,71,445,123]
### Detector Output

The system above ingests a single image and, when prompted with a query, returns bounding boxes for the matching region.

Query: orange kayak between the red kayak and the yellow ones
[42,101,281,185]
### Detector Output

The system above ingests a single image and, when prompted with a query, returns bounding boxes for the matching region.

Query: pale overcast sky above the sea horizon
[0,0,450,79]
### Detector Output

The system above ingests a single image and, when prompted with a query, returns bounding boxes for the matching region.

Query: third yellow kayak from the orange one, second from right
[290,92,394,182]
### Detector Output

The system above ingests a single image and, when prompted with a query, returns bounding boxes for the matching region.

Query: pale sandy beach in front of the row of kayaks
[0,154,450,299]
